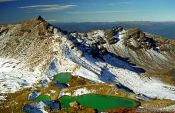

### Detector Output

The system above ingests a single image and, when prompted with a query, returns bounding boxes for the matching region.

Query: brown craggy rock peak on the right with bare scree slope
[107,29,175,71]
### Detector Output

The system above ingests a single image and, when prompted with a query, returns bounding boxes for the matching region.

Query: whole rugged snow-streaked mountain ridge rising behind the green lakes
[0,16,175,100]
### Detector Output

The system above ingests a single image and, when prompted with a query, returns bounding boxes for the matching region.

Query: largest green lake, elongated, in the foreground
[59,94,140,111]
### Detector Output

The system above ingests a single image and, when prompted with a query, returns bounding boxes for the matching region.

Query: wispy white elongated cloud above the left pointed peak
[19,4,77,12]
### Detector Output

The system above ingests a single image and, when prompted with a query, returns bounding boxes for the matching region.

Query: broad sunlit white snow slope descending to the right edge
[110,67,175,100]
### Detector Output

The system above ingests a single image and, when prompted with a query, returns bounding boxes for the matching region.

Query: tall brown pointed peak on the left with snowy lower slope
[0,17,76,99]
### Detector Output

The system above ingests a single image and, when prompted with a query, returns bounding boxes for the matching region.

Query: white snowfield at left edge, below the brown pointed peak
[0,58,43,100]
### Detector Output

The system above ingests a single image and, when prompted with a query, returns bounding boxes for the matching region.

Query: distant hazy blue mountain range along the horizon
[53,21,175,39]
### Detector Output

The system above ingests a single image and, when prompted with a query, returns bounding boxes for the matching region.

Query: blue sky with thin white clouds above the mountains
[0,0,175,23]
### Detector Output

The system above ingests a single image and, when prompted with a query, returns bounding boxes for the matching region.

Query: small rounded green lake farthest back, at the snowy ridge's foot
[54,72,72,84]
